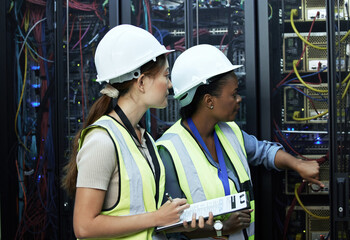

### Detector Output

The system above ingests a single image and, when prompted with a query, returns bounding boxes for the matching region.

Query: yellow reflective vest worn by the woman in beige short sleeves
[79,116,166,240]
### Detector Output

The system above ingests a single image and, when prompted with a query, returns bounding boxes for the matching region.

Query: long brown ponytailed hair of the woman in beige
[61,54,166,197]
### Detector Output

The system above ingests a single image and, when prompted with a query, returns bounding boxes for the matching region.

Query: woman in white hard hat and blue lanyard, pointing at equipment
[157,44,323,240]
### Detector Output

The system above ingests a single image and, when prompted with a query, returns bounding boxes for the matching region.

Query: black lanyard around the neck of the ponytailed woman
[114,104,160,203]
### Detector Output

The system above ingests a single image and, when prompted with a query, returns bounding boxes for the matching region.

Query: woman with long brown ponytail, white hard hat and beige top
[63,25,211,239]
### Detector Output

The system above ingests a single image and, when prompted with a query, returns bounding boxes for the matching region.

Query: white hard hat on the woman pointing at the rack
[171,44,242,107]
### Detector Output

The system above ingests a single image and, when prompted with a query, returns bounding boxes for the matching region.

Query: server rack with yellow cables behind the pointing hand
[258,0,349,239]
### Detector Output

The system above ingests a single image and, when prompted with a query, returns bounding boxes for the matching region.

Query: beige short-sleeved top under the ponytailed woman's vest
[76,124,154,209]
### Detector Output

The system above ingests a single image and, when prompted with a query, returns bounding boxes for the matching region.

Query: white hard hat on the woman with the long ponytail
[95,24,173,84]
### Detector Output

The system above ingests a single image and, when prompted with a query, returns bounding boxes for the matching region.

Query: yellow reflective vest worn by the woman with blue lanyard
[156,119,255,240]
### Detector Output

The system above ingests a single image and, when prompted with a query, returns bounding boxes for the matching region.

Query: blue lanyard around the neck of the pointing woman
[187,118,230,196]
